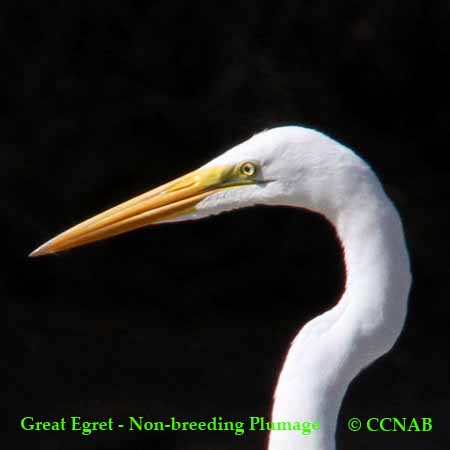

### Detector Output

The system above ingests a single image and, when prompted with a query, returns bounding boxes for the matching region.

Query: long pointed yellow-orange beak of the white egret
[30,166,252,257]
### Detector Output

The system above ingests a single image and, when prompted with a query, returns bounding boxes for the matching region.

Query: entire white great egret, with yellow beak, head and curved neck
[30,126,411,450]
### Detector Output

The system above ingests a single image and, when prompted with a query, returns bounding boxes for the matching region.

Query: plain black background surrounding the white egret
[0,0,450,450]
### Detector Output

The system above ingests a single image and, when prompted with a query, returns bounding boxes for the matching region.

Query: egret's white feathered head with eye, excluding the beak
[176,126,371,221]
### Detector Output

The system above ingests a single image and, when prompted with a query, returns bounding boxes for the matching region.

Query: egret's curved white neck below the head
[269,182,411,450]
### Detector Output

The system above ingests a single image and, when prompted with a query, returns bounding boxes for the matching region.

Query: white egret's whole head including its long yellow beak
[30,126,366,256]
